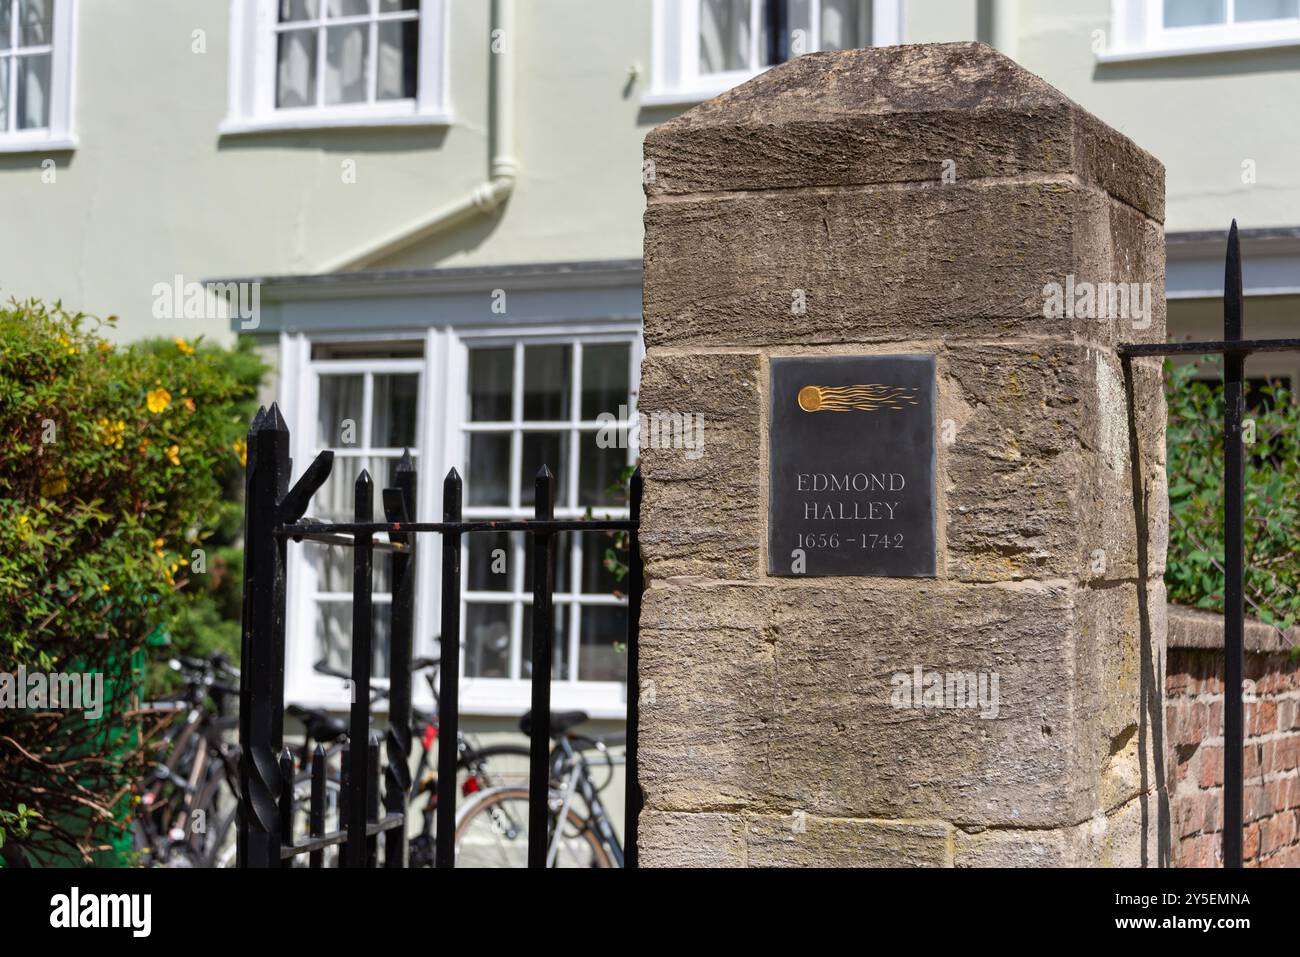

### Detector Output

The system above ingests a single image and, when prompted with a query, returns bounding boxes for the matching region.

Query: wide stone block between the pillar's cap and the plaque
[644,182,1164,348]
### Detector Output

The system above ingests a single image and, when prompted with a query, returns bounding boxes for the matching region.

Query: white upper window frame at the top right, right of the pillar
[1097,0,1300,62]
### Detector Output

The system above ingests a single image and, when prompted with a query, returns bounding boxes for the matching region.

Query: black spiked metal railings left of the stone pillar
[237,404,642,867]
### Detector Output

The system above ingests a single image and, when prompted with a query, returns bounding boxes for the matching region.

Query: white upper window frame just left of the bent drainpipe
[220,0,451,135]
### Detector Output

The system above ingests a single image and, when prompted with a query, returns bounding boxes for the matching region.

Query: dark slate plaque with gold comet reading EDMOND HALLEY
[767,355,935,577]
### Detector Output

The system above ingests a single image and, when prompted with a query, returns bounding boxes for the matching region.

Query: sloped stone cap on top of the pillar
[645,43,1165,221]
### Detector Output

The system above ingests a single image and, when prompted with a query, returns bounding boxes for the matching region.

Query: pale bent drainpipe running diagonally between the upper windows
[317,0,519,273]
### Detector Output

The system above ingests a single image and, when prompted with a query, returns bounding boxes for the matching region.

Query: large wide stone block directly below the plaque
[641,580,1158,827]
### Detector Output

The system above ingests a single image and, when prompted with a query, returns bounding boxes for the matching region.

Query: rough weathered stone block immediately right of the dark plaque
[940,342,1167,581]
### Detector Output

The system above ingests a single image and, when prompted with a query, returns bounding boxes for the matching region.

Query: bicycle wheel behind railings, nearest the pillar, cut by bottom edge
[456,788,611,867]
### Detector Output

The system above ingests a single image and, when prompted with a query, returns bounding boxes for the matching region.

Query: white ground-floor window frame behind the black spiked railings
[287,317,644,718]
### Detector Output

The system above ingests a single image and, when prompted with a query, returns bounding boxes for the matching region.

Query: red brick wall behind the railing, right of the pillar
[1165,629,1300,867]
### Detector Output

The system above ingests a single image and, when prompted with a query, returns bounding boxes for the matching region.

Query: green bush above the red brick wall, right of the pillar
[1165,358,1300,628]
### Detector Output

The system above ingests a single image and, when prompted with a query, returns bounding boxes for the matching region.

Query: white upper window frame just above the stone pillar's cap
[641,0,902,107]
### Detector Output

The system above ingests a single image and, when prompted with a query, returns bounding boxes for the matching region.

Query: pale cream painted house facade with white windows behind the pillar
[0,0,1300,719]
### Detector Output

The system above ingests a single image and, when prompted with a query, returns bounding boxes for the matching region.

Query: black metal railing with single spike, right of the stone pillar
[1118,220,1300,867]
